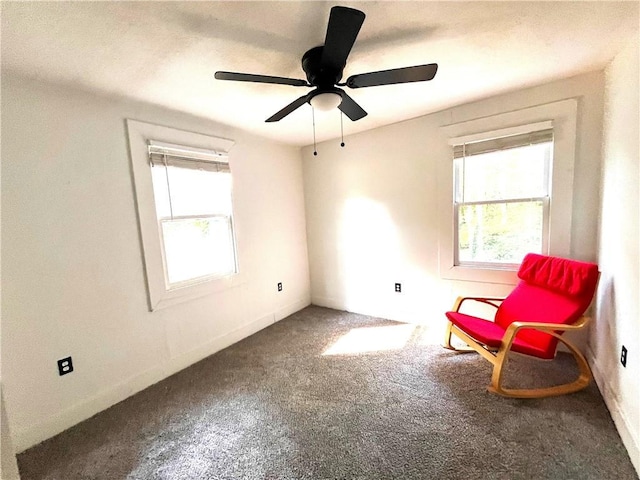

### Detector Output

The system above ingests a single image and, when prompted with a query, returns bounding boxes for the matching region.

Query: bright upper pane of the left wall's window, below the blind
[151,166,231,218]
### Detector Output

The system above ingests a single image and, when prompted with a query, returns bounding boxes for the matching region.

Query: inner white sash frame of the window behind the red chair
[449,121,553,270]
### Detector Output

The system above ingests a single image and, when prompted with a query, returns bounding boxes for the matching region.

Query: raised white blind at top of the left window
[148,140,231,172]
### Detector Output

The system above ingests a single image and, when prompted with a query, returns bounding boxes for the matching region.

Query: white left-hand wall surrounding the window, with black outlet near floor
[2,72,310,451]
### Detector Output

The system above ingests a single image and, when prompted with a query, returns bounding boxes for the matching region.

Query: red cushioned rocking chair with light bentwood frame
[444,253,599,398]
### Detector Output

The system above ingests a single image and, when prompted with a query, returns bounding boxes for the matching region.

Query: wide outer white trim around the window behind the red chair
[438,98,578,284]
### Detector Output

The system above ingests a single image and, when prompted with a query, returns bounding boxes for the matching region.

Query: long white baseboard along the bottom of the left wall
[12,299,309,453]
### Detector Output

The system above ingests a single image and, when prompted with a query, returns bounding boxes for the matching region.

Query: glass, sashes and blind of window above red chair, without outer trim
[453,129,553,268]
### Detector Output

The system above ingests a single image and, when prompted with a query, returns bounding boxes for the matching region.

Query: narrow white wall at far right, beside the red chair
[589,37,640,472]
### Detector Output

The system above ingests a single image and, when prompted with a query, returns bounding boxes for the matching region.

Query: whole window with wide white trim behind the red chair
[440,98,578,285]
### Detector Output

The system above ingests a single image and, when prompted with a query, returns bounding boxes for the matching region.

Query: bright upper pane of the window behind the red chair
[455,143,552,202]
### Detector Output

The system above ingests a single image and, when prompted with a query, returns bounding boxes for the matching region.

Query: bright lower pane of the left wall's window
[161,217,236,285]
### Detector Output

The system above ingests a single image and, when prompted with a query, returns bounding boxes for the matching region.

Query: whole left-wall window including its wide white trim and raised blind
[127,120,243,311]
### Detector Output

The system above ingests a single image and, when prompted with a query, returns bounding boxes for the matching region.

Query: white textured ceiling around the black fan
[1,1,638,146]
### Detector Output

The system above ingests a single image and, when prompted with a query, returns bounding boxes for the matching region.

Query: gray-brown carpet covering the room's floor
[18,307,638,480]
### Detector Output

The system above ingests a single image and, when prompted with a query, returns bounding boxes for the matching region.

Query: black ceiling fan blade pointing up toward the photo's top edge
[320,7,365,72]
